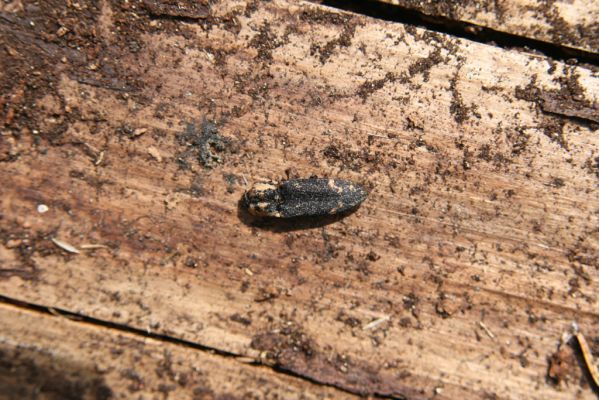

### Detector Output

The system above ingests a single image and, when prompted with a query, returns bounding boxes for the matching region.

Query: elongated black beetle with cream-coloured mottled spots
[243,178,368,218]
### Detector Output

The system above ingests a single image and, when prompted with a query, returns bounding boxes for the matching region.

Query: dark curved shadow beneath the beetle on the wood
[237,197,360,233]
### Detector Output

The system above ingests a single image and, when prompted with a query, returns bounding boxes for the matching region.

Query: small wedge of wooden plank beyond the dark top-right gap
[372,0,599,53]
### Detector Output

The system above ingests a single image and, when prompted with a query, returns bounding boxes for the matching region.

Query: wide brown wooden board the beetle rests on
[0,0,599,399]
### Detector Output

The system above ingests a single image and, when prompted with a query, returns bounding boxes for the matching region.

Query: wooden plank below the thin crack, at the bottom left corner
[0,304,354,399]
